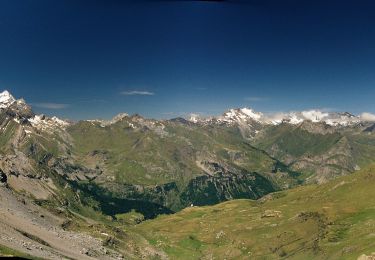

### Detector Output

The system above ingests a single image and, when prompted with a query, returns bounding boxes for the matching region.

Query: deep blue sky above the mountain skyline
[0,0,375,119]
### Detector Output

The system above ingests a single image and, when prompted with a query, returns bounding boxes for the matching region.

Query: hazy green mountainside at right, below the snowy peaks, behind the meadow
[253,121,375,183]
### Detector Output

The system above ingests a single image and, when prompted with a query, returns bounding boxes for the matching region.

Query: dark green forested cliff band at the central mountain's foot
[93,167,277,212]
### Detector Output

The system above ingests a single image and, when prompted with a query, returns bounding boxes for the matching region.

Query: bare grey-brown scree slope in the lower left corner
[0,185,123,259]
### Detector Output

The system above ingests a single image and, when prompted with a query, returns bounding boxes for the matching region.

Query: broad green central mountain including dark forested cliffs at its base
[68,116,298,210]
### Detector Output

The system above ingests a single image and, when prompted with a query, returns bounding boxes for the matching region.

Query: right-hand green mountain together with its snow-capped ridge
[190,105,375,183]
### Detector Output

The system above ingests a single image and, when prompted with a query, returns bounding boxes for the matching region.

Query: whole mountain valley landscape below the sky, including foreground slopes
[0,91,375,259]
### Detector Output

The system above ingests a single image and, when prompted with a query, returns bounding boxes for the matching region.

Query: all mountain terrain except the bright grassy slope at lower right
[0,91,375,259]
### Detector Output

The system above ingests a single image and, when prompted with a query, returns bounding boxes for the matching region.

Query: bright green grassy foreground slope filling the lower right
[136,166,375,259]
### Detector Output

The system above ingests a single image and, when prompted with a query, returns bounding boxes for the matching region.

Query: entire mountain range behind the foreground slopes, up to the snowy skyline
[0,91,375,212]
